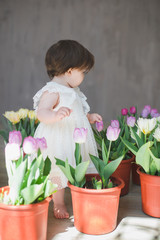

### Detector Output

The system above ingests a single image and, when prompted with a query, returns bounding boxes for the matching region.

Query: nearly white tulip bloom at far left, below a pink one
[5,143,21,161]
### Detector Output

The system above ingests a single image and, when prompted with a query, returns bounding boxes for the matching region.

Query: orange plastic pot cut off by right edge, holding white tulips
[137,167,160,218]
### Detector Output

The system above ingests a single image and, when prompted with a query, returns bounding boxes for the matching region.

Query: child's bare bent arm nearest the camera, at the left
[37,91,72,124]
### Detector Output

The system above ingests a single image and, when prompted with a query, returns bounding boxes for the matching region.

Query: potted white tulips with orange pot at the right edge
[122,117,160,217]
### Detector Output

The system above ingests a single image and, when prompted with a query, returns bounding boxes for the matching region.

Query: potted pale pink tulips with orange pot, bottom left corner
[0,130,56,240]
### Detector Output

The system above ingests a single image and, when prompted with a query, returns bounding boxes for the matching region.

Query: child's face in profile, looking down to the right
[67,69,85,88]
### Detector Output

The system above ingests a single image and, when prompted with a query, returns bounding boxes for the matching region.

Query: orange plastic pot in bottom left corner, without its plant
[0,187,51,240]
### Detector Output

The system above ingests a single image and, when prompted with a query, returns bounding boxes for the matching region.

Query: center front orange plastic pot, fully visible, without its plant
[68,174,124,235]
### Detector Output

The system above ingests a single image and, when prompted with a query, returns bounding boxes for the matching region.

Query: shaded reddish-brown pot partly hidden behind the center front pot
[112,155,134,196]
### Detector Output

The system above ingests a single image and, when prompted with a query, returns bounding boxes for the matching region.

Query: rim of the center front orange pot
[68,173,125,194]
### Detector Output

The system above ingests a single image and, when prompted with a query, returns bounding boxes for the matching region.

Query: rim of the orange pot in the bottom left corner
[0,186,52,211]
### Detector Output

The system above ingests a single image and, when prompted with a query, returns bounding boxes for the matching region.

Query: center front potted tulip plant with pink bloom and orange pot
[55,128,124,235]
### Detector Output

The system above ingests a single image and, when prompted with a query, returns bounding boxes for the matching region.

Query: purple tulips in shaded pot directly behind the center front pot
[93,107,136,196]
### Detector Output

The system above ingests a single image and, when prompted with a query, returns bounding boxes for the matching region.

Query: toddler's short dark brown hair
[45,40,94,79]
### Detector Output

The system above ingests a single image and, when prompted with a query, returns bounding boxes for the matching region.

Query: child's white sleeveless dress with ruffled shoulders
[33,81,98,189]
